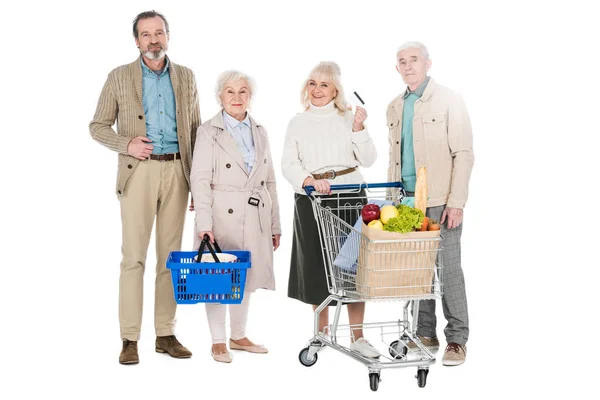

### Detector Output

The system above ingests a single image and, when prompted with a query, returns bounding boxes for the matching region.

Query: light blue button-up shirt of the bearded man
[140,58,179,154]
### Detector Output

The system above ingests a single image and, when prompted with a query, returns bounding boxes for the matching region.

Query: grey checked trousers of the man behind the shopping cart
[417,206,469,346]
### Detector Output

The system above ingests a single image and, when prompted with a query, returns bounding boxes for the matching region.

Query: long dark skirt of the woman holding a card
[288,193,365,306]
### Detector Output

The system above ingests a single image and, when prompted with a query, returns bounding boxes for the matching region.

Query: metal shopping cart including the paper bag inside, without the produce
[298,182,442,391]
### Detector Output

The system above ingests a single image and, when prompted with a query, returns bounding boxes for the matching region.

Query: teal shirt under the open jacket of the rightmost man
[400,77,429,192]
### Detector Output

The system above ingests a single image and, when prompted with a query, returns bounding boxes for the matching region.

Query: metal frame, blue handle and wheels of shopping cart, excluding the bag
[298,182,443,391]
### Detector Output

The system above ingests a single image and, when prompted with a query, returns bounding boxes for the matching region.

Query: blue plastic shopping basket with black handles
[167,235,251,304]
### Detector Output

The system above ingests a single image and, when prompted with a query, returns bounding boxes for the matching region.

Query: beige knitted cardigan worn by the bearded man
[90,58,200,196]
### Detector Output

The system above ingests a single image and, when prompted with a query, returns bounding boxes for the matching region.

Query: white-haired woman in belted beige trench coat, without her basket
[190,71,281,362]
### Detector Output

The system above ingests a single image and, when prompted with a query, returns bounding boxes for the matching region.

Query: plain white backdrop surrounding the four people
[0,0,600,399]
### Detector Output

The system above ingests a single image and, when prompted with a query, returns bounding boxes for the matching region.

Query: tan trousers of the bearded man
[119,160,189,341]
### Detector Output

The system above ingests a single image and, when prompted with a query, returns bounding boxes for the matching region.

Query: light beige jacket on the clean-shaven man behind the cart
[387,78,474,208]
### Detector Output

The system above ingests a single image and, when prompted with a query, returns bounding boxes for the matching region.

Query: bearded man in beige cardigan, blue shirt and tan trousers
[90,11,200,364]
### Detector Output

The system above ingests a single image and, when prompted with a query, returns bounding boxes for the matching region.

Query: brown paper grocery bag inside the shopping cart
[356,224,441,298]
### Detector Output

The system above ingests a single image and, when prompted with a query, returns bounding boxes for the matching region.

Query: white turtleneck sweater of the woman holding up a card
[281,101,377,194]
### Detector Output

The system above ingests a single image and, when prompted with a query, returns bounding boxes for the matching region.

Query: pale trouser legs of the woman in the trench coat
[206,293,250,344]
